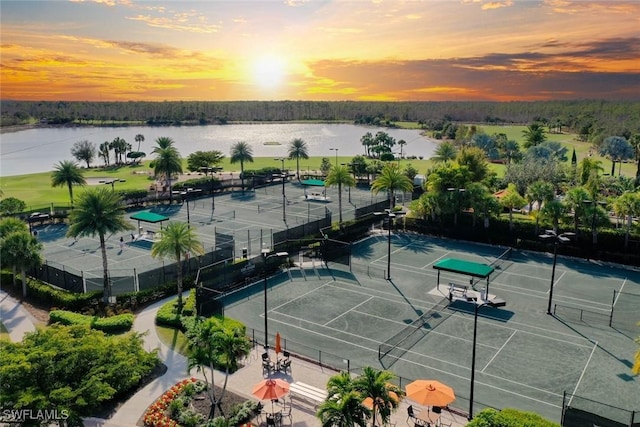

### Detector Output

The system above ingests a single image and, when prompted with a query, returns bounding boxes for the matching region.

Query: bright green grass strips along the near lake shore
[0,122,636,209]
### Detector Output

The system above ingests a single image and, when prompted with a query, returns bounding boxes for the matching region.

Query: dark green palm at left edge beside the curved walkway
[0,230,43,298]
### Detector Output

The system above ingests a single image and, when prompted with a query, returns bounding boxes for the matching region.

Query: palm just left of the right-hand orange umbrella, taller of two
[353,366,404,427]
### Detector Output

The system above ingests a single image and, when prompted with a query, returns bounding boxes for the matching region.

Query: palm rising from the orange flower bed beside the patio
[187,317,251,419]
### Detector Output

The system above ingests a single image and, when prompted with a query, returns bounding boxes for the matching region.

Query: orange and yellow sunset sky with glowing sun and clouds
[0,0,640,101]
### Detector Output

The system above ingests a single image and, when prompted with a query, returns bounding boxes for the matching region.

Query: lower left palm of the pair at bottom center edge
[316,391,371,427]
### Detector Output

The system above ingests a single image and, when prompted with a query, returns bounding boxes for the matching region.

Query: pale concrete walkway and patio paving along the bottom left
[0,291,467,427]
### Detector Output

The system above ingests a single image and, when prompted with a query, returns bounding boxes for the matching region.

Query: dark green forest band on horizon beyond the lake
[0,100,640,138]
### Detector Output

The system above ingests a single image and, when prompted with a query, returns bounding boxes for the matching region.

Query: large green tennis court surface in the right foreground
[225,234,640,422]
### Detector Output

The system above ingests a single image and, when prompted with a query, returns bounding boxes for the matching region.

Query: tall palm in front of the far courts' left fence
[67,187,133,304]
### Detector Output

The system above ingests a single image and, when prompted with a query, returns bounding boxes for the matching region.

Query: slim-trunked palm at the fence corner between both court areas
[151,222,204,313]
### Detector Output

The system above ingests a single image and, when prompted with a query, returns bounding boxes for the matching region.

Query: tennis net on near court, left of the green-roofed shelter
[378,298,451,368]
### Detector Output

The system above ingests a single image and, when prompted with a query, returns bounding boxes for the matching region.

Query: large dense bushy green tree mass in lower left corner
[0,324,158,425]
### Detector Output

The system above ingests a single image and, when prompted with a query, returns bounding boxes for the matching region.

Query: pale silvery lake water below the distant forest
[0,123,437,176]
